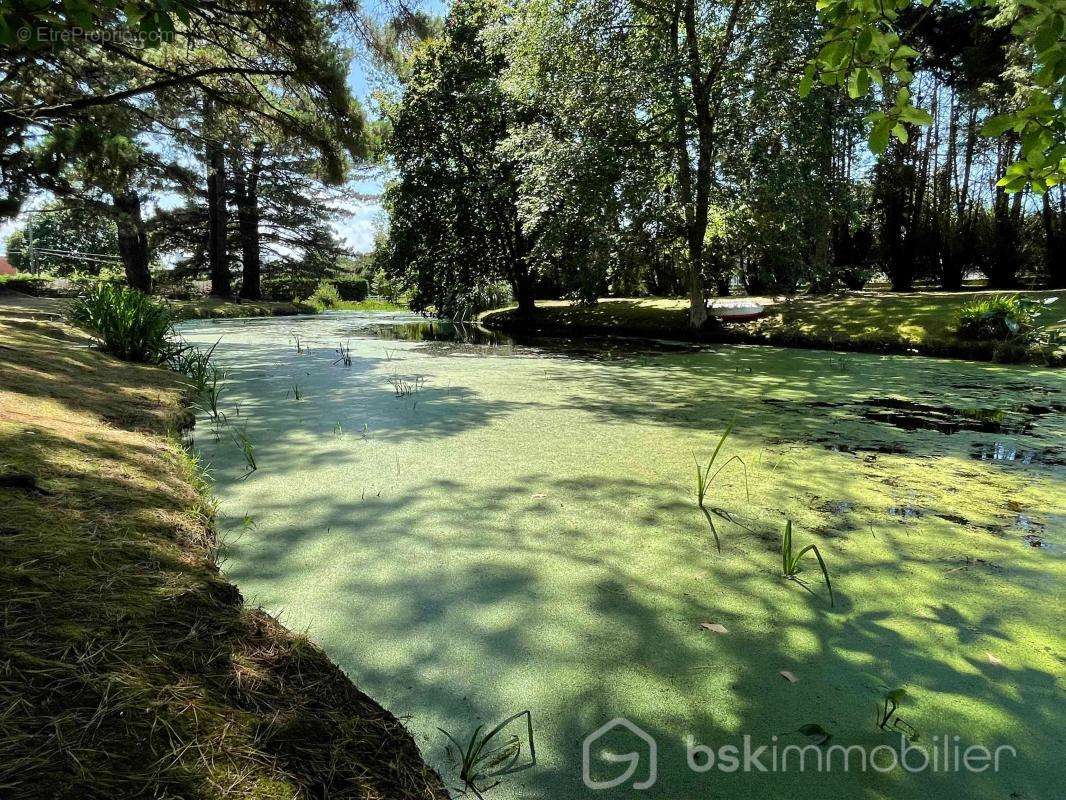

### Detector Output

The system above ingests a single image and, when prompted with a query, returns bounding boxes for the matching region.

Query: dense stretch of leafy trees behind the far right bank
[375,0,1066,325]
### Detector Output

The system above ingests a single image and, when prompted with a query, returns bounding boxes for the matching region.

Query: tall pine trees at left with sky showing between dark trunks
[0,0,370,299]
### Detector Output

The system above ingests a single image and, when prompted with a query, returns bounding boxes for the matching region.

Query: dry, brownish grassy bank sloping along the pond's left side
[0,304,447,800]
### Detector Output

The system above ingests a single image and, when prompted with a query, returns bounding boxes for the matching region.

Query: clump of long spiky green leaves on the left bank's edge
[70,283,176,364]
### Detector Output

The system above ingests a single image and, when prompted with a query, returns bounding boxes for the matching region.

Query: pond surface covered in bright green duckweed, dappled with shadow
[182,315,1066,800]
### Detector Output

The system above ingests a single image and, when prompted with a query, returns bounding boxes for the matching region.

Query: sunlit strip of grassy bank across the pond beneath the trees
[482,291,1066,361]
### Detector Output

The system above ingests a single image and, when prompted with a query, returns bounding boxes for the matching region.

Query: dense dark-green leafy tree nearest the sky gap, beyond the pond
[374,0,532,318]
